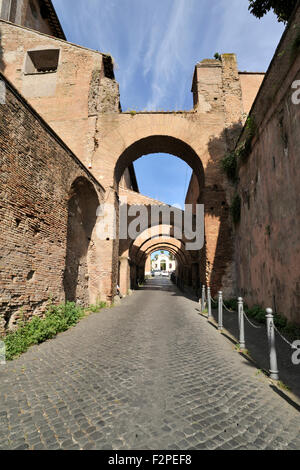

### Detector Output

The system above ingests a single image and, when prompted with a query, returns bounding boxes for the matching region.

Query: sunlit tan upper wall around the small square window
[0,21,119,166]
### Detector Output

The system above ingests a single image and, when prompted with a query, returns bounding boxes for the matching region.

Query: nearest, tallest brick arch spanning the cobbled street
[91,107,238,297]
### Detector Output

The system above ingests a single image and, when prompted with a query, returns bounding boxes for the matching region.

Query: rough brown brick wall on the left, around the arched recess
[0,76,104,331]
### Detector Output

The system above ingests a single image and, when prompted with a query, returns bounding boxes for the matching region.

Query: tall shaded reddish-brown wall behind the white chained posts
[236,3,300,323]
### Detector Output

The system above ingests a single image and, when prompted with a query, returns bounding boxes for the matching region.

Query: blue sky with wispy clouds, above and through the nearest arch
[53,0,283,204]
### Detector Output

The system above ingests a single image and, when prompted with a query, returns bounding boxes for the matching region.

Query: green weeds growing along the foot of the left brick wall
[3,302,106,361]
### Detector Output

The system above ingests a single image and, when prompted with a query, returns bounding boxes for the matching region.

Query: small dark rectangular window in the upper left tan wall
[25,49,59,75]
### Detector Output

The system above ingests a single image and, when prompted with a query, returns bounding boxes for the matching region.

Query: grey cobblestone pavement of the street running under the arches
[0,279,300,450]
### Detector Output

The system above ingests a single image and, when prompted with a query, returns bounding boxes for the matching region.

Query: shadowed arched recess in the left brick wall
[63,178,99,306]
